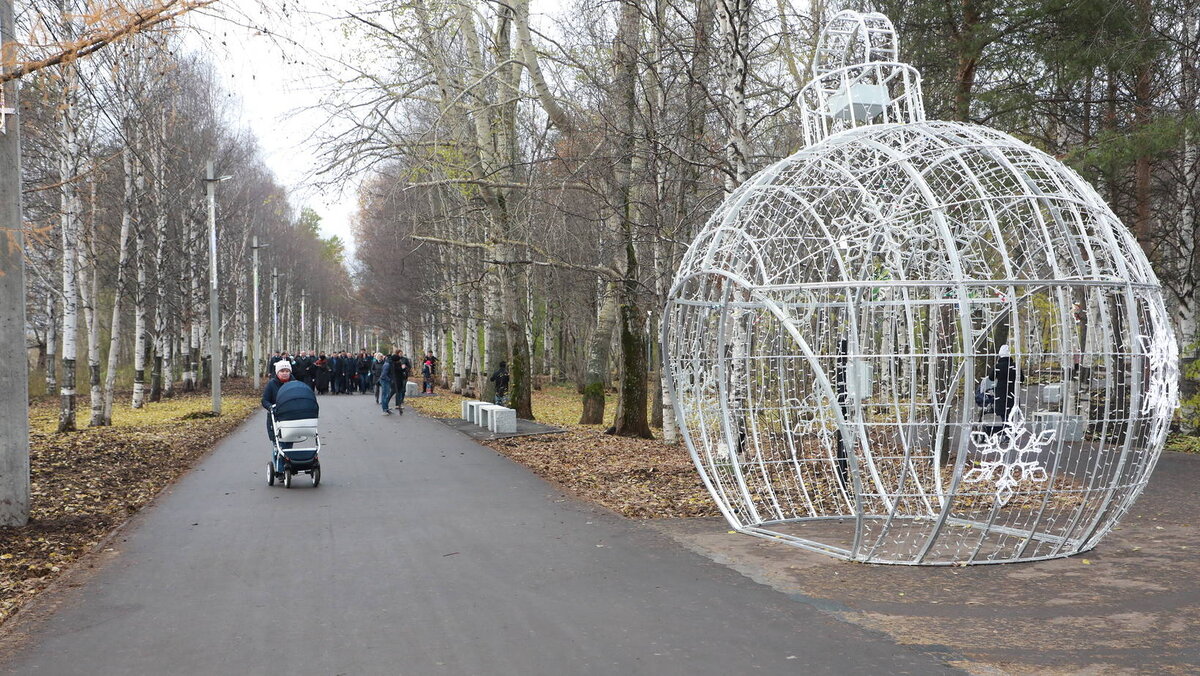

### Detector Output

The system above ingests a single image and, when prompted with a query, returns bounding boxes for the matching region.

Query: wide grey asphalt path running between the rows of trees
[0,395,953,676]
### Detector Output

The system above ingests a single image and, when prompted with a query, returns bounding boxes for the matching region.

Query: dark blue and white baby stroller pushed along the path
[266,381,320,489]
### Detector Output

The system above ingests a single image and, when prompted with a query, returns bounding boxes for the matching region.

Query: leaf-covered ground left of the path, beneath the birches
[0,385,258,622]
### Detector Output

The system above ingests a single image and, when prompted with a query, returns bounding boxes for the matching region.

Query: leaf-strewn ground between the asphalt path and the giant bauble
[406,387,718,519]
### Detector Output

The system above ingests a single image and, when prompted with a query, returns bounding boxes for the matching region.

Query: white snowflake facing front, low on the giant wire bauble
[962,406,1055,507]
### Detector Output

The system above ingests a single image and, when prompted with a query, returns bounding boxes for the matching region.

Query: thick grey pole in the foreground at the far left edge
[0,0,29,526]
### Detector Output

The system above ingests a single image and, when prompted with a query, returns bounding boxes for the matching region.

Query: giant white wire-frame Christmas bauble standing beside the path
[662,12,1177,564]
